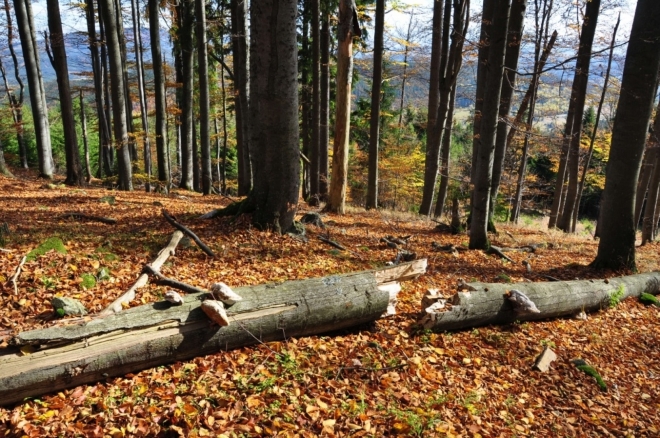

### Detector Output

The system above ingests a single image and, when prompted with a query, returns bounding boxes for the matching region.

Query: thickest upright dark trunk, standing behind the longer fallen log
[249,0,300,233]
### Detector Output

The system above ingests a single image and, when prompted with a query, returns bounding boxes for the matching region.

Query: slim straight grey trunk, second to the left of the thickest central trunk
[195,0,213,195]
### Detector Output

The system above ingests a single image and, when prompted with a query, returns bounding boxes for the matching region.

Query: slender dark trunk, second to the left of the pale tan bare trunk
[307,0,320,206]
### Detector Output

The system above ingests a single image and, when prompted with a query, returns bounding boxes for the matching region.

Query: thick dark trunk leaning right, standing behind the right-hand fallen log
[592,0,660,269]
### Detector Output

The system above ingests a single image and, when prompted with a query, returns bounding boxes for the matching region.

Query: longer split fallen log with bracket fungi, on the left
[0,260,426,405]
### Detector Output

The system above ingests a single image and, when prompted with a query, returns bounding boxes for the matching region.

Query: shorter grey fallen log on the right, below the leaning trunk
[420,272,660,331]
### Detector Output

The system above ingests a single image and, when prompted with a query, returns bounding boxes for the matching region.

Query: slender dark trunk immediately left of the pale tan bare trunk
[319,11,330,201]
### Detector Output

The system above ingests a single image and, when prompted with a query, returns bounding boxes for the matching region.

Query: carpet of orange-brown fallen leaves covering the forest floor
[0,175,660,438]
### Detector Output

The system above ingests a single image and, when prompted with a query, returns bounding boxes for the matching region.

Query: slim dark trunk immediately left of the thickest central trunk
[231,0,255,196]
